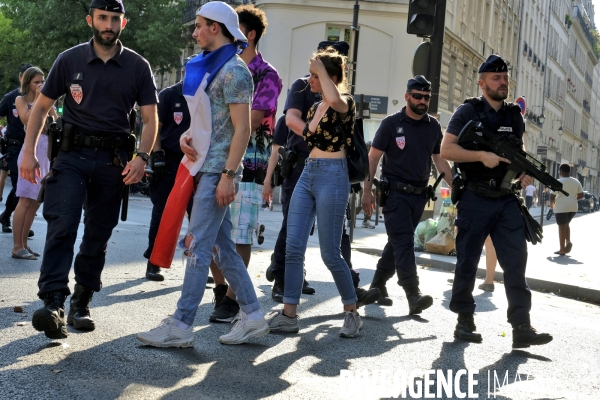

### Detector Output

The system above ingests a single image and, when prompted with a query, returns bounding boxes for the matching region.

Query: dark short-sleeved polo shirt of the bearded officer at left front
[42,40,158,136]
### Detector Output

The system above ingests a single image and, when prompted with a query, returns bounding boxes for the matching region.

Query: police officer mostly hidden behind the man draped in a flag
[144,56,193,281]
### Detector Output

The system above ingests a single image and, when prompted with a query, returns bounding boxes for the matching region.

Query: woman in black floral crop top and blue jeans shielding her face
[269,47,362,337]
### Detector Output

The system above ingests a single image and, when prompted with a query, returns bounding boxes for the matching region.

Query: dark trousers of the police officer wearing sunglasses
[384,191,427,288]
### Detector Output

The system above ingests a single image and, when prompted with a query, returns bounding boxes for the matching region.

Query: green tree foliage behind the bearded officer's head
[0,0,184,79]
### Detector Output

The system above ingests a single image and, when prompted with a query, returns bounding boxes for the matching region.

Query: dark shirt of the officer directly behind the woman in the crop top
[283,78,321,157]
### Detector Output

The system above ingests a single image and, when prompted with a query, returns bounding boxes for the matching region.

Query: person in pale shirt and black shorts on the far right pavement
[550,164,583,256]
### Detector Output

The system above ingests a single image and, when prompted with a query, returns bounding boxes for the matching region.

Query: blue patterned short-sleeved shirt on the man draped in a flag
[200,55,254,174]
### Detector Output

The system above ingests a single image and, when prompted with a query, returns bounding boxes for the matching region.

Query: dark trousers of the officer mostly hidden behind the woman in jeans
[271,163,360,287]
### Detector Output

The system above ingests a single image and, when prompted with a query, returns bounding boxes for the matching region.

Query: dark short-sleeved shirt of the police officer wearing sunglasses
[372,107,442,186]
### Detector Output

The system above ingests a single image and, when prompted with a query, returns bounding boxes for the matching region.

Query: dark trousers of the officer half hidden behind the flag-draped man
[145,156,193,258]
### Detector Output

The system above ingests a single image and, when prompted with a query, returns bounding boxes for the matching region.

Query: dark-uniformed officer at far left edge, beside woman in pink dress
[0,64,33,233]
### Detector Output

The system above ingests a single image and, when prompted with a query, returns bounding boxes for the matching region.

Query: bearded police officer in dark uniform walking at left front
[20,0,158,339]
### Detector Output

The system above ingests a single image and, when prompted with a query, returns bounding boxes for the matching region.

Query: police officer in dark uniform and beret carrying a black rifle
[442,55,552,348]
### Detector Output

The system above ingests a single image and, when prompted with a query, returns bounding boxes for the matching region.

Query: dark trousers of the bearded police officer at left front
[38,148,125,296]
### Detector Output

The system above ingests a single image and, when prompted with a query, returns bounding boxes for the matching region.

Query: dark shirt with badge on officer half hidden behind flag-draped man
[158,82,191,155]
